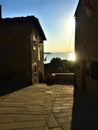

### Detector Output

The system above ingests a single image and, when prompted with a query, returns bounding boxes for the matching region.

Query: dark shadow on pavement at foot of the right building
[71,91,98,130]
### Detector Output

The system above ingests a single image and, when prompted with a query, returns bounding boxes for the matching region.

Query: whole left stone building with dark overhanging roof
[0,6,46,85]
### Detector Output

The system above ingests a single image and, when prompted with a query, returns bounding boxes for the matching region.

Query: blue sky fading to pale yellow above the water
[0,0,79,52]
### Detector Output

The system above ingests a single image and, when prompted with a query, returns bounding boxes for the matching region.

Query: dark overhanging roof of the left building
[0,16,46,40]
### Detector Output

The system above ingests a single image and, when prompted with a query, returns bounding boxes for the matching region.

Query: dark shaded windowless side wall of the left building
[0,23,31,85]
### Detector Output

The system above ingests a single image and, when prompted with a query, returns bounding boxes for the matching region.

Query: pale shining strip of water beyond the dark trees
[44,52,74,63]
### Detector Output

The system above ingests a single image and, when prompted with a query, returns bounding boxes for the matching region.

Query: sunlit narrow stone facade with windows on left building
[30,29,44,83]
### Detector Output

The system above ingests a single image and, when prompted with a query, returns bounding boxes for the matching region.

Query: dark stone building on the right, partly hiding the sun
[75,0,98,97]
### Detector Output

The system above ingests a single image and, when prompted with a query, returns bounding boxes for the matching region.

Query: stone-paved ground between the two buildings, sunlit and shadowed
[0,84,98,130]
